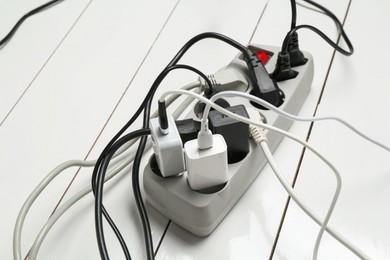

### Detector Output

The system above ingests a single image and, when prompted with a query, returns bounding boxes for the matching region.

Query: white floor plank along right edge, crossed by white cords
[277,1,390,259]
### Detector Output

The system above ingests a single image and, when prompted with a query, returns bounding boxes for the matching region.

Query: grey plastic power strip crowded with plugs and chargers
[143,45,314,236]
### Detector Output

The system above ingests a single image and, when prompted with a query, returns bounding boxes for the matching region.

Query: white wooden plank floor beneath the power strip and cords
[0,0,390,259]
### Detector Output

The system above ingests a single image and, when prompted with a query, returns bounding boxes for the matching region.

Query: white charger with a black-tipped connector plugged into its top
[150,115,185,177]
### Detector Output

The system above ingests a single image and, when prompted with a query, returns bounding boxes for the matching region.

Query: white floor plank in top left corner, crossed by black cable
[0,0,90,123]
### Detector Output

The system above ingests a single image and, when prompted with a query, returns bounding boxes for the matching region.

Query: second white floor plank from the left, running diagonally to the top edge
[0,0,176,259]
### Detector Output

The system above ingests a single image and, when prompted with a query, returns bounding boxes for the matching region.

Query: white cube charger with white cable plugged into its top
[184,135,228,190]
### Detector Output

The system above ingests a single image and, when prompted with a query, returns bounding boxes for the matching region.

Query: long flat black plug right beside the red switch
[244,49,283,107]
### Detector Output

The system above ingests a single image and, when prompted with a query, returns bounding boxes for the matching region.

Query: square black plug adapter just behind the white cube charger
[209,105,249,164]
